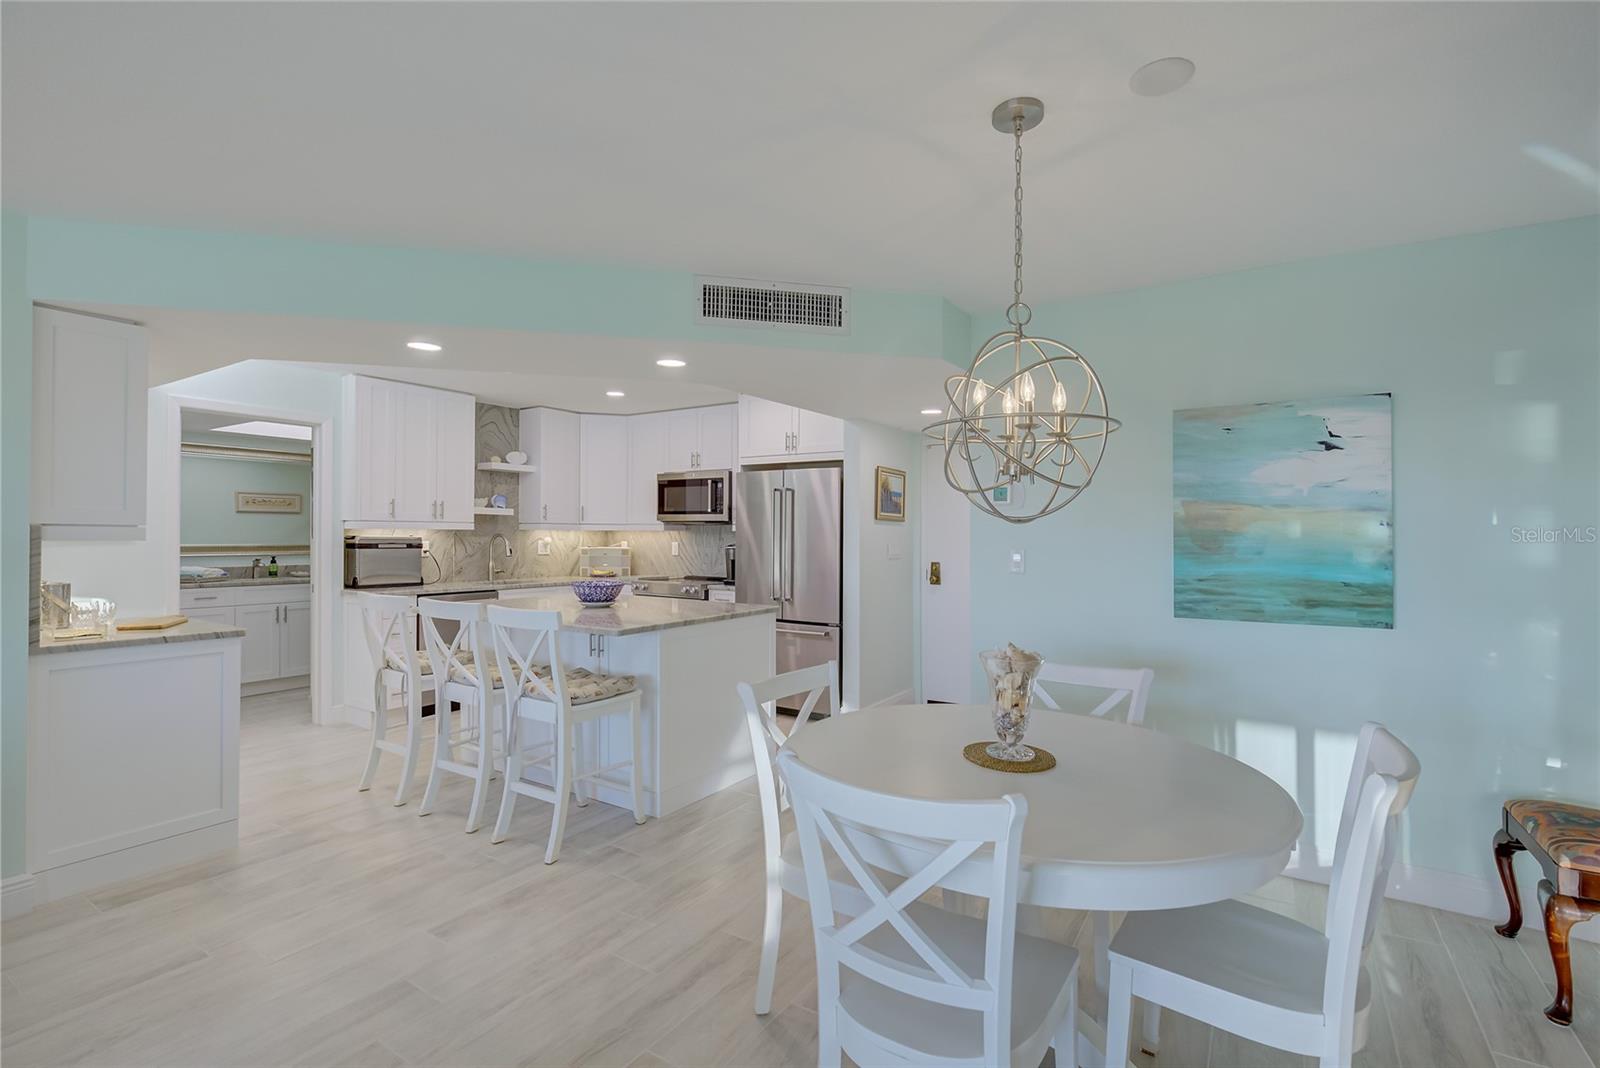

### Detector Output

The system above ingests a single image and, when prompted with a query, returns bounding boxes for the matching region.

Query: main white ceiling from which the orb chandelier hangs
[0,2,1600,310]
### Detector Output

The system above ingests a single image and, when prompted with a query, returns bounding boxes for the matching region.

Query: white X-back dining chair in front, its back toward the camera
[778,748,1078,1068]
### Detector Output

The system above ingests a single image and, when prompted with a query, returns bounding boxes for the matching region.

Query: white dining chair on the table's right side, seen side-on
[1106,723,1422,1068]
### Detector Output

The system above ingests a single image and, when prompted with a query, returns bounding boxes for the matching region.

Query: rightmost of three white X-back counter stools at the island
[488,604,645,863]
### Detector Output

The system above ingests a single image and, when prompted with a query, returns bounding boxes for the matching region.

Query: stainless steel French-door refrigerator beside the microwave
[734,467,845,697]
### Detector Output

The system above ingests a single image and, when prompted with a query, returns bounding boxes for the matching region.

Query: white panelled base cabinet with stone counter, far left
[27,620,245,902]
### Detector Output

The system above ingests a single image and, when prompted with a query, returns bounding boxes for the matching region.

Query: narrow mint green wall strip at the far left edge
[0,211,34,878]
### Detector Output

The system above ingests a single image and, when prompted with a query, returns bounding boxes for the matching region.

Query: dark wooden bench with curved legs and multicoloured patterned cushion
[1494,799,1600,1026]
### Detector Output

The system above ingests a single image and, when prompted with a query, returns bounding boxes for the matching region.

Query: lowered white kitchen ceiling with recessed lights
[103,305,955,430]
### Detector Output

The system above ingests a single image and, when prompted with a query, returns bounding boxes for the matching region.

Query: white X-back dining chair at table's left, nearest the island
[736,660,853,1015]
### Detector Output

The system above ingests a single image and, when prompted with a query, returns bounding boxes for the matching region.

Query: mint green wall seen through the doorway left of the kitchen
[178,456,310,546]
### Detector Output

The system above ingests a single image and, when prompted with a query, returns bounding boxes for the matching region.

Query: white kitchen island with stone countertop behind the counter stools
[485,590,778,817]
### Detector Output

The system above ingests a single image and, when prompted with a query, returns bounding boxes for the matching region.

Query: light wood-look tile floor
[0,692,1600,1068]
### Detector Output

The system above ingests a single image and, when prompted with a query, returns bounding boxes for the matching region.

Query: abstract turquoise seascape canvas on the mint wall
[1173,393,1395,630]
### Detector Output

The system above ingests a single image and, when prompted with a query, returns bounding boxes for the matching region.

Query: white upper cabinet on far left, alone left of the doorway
[29,309,149,539]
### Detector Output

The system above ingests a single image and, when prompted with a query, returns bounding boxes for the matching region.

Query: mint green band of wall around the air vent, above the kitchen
[29,217,968,357]
